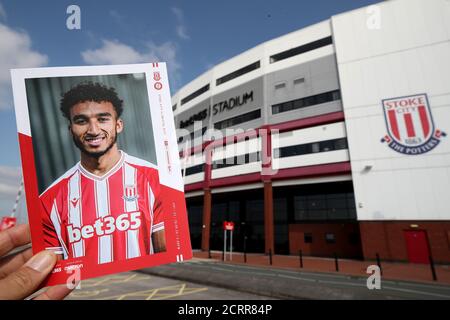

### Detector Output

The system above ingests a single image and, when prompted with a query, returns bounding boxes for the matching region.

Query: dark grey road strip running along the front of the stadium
[140,258,450,300]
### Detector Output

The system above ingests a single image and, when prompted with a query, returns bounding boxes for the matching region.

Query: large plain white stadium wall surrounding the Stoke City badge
[332,0,450,220]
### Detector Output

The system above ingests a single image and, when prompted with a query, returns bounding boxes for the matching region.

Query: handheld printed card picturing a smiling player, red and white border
[11,63,192,285]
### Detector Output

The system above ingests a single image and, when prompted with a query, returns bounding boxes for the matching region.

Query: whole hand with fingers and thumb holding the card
[0,224,72,300]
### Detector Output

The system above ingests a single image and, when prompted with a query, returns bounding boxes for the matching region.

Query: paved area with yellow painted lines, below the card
[66,272,270,300]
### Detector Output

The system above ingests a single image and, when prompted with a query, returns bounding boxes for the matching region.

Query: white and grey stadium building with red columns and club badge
[172,0,450,263]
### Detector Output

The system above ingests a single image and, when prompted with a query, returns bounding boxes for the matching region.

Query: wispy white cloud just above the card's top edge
[81,39,181,87]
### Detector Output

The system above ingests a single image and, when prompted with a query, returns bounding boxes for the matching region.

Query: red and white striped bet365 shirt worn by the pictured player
[40,151,164,264]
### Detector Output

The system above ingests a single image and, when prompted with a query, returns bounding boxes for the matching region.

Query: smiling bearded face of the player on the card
[69,101,123,157]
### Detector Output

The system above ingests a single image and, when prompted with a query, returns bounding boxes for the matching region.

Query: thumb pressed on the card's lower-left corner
[0,250,56,300]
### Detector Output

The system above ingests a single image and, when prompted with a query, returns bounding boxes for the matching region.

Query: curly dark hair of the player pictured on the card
[60,82,123,121]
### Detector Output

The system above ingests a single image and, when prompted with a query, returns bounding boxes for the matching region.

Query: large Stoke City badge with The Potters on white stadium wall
[381,94,446,155]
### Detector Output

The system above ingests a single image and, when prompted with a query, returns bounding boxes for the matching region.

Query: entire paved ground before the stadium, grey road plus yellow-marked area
[67,256,450,300]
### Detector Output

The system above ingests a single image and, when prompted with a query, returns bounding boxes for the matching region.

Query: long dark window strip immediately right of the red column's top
[273,138,347,158]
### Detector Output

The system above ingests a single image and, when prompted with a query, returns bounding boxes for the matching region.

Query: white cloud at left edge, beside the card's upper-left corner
[0,22,48,110]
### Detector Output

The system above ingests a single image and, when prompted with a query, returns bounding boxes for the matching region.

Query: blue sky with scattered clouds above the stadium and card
[0,0,379,215]
